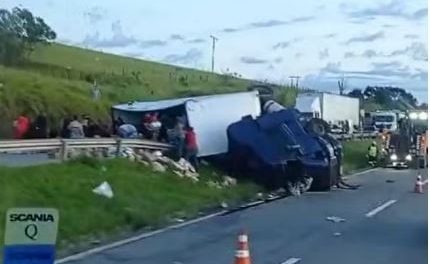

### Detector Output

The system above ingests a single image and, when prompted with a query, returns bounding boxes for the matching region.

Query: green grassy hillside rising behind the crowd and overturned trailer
[0,44,262,137]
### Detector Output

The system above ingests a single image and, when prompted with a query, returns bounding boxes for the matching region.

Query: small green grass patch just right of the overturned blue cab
[343,139,374,174]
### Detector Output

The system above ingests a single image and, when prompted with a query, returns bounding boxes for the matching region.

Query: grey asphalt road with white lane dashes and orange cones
[62,170,427,264]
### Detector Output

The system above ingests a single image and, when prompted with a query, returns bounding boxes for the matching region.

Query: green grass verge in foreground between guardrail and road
[0,159,259,253]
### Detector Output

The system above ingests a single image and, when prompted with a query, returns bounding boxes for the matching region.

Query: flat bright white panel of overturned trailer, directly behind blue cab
[186,92,261,157]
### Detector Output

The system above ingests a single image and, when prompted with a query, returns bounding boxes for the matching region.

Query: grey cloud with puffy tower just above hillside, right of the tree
[82,20,137,48]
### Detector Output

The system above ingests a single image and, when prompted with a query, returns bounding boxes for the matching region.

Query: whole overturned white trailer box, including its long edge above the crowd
[112,91,261,157]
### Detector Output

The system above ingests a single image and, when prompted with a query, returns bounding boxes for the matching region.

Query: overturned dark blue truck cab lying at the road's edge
[227,101,357,195]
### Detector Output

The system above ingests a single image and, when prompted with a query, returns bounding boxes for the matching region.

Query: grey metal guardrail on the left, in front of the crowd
[0,138,172,160]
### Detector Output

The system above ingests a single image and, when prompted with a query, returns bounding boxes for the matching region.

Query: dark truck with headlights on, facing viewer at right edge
[382,111,428,168]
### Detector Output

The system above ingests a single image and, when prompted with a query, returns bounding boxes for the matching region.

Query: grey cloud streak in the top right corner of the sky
[340,0,427,20]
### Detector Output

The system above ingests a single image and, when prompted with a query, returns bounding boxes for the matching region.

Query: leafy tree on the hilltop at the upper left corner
[0,7,57,64]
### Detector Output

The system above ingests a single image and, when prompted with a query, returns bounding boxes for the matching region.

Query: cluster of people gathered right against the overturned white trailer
[114,112,198,167]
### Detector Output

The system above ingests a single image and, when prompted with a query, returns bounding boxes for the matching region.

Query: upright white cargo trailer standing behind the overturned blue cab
[296,92,360,126]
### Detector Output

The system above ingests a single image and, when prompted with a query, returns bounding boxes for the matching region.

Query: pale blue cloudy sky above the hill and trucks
[0,0,428,102]
